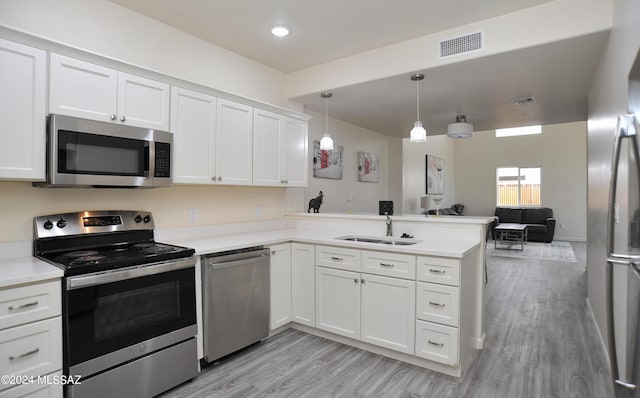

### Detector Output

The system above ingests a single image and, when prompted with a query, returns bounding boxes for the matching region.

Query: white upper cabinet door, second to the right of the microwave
[215,98,253,185]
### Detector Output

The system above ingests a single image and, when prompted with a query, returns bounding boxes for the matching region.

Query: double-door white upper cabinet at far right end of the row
[253,109,308,187]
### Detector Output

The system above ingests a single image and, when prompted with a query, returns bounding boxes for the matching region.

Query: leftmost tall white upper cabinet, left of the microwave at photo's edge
[0,39,47,181]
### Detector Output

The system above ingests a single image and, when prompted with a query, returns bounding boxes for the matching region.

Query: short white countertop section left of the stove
[0,256,63,288]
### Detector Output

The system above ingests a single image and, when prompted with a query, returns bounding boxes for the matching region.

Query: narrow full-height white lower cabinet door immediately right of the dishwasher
[269,243,291,330]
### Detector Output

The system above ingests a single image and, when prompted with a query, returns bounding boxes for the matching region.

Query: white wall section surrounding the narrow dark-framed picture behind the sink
[402,135,458,214]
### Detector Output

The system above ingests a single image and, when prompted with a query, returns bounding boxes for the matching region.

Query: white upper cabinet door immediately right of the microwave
[169,86,216,184]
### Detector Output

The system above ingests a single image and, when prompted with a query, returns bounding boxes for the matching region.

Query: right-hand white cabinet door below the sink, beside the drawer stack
[360,274,416,355]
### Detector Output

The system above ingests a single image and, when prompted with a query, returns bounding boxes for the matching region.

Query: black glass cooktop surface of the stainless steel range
[38,242,195,275]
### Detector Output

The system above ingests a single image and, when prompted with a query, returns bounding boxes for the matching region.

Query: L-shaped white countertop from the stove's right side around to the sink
[168,228,480,258]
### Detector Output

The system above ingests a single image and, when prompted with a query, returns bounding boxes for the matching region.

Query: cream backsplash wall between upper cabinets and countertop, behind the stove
[0,181,286,242]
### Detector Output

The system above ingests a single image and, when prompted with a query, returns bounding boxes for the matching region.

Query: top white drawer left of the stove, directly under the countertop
[0,280,62,329]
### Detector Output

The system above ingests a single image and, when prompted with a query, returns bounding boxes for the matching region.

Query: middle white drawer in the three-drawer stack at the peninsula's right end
[416,282,460,326]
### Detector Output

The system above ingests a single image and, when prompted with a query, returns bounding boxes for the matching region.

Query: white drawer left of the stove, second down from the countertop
[0,317,62,389]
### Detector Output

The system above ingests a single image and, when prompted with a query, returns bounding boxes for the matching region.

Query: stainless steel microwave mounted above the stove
[33,115,173,188]
